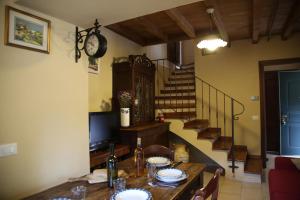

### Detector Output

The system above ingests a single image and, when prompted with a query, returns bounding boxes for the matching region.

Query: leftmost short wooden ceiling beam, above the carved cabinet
[135,17,168,42]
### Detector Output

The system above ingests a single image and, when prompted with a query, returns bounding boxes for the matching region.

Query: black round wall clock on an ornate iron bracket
[75,19,107,62]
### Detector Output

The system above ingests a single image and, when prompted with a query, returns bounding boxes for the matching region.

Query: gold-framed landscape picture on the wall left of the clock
[5,6,51,53]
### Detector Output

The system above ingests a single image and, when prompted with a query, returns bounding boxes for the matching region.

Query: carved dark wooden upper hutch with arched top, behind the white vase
[112,55,155,126]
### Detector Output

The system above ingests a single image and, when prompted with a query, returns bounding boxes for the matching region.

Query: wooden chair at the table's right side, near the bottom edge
[191,168,223,200]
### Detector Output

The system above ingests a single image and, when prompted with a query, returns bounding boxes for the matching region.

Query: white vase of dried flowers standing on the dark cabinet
[118,91,132,127]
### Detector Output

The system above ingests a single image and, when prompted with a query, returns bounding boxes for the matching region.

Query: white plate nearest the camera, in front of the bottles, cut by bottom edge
[111,188,152,200]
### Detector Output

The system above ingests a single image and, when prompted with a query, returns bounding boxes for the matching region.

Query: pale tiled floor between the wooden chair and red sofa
[204,172,269,200]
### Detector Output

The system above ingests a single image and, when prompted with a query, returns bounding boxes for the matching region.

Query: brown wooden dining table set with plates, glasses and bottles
[25,158,205,200]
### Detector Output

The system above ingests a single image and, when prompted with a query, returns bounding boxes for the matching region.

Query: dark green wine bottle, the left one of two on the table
[106,143,118,187]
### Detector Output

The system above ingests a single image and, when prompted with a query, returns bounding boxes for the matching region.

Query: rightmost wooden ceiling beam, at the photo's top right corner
[281,0,300,40]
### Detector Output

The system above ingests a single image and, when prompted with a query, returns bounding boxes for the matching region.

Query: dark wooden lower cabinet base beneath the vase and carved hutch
[120,122,170,154]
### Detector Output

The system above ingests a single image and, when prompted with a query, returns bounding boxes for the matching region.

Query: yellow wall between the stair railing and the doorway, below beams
[194,34,300,155]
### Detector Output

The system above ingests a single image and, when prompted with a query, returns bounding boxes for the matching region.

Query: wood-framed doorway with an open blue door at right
[259,58,300,167]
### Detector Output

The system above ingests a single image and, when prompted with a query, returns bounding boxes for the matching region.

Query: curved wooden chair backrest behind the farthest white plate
[144,144,174,160]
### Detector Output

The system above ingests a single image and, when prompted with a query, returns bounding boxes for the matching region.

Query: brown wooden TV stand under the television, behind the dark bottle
[90,144,130,168]
